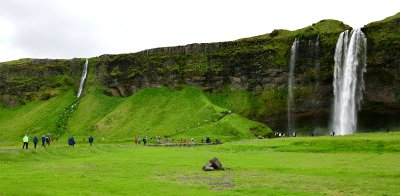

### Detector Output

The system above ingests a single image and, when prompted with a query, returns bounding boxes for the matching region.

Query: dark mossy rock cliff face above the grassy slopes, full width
[0,14,400,132]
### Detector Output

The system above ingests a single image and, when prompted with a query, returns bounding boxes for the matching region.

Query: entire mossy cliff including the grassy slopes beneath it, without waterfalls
[0,14,400,140]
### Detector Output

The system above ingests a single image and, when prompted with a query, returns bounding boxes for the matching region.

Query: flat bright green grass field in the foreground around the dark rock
[0,132,400,195]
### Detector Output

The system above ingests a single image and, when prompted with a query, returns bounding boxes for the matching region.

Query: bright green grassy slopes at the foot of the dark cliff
[0,84,271,144]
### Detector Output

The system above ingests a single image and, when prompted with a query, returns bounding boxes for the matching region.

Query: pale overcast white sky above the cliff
[0,0,400,62]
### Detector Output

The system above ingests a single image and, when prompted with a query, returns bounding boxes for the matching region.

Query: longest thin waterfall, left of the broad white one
[287,38,299,133]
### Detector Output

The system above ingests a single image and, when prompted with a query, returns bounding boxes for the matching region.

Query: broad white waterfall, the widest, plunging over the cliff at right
[332,29,367,135]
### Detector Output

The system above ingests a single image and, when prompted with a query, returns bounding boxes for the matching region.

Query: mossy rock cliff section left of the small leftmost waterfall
[0,59,84,107]
